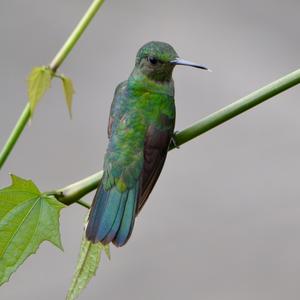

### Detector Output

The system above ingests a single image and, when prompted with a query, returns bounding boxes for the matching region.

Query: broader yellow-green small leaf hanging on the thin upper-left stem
[28,66,53,114]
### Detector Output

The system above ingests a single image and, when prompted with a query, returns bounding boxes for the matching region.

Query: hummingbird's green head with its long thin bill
[135,41,209,81]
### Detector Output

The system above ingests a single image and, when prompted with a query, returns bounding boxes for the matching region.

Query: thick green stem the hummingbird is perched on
[54,69,300,205]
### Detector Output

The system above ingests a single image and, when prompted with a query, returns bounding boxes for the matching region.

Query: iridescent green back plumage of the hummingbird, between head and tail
[103,77,175,191]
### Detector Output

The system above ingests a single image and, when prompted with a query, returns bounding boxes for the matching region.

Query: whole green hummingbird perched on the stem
[85,41,209,247]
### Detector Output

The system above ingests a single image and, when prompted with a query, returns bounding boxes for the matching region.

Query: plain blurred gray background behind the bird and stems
[0,0,300,300]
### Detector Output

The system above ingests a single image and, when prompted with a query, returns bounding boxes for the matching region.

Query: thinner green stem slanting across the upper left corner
[0,0,104,170]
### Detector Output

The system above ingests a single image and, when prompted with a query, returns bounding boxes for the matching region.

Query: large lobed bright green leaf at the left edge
[0,175,65,285]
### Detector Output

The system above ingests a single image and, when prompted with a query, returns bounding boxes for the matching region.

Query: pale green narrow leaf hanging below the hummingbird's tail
[66,220,110,300]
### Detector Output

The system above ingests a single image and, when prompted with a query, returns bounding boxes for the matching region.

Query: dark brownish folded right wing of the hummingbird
[136,116,174,214]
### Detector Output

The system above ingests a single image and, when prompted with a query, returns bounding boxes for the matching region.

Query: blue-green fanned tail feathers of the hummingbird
[86,182,139,247]
